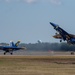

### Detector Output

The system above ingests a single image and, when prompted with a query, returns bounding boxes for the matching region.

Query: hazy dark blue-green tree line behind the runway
[0,42,75,51]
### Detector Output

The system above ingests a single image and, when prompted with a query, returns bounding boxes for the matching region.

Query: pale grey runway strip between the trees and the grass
[0,50,74,56]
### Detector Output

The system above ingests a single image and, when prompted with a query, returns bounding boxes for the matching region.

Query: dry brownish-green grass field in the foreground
[0,56,75,75]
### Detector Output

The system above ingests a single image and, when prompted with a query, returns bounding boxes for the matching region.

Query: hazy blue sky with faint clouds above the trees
[0,0,75,43]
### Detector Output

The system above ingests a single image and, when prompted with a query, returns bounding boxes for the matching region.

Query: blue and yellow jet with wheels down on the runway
[0,41,25,55]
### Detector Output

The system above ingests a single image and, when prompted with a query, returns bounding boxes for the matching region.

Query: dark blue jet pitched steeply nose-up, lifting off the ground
[50,22,75,44]
